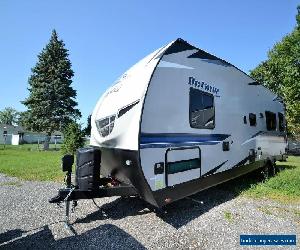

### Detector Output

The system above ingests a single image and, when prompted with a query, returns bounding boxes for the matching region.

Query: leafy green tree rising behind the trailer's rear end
[251,6,300,136]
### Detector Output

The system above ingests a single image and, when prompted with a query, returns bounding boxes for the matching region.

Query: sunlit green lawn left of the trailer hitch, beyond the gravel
[0,144,63,181]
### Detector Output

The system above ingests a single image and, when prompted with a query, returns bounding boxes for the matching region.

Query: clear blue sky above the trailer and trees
[0,0,300,124]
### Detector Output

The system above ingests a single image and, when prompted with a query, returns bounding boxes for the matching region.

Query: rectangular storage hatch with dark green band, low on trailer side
[165,147,201,186]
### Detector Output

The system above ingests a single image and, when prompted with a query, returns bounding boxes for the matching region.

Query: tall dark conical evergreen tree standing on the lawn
[22,30,81,149]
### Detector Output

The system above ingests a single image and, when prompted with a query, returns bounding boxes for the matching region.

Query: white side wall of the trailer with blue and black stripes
[140,43,286,191]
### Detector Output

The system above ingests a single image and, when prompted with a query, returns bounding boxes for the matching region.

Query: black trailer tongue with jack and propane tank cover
[49,147,138,226]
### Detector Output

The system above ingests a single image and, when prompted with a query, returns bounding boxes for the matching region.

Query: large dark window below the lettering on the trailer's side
[190,88,215,129]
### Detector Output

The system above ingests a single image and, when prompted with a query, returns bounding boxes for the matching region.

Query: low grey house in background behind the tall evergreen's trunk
[0,123,63,145]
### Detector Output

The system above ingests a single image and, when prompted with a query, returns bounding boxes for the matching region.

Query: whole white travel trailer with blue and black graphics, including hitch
[50,39,287,221]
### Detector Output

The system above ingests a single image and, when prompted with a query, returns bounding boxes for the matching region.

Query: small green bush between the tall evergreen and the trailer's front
[61,122,84,155]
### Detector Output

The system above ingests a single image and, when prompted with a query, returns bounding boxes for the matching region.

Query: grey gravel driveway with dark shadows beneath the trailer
[0,174,300,249]
